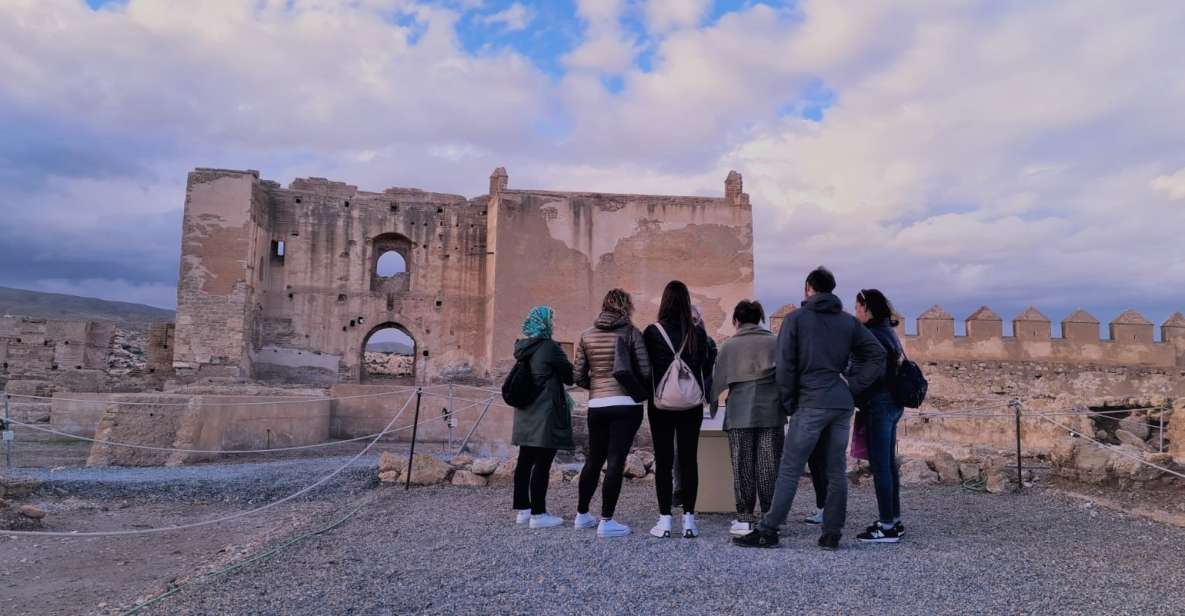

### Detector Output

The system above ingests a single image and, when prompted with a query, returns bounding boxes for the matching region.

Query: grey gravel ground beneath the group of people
[134,485,1185,615]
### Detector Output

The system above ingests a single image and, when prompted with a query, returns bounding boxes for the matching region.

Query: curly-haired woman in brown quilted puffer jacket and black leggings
[575,289,651,537]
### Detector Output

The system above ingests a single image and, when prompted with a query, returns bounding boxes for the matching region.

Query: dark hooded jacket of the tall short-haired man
[776,293,885,413]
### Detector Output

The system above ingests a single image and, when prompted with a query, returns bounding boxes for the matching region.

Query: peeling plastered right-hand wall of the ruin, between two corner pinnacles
[487,172,754,371]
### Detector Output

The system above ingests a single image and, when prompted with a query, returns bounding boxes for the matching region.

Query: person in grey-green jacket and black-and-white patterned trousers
[709,300,786,535]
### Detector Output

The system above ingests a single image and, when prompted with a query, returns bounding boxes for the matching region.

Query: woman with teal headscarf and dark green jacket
[511,306,576,528]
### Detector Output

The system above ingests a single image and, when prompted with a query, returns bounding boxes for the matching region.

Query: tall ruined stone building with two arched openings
[171,163,752,385]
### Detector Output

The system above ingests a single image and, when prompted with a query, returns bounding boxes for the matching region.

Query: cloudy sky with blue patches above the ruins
[0,0,1185,333]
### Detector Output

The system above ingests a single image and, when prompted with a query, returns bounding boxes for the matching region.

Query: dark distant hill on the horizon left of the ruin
[0,287,174,325]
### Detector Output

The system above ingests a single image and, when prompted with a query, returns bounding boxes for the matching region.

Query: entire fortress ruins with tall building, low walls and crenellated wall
[0,168,1185,476]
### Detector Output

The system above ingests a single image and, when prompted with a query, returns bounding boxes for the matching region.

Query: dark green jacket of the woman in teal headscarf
[511,338,576,449]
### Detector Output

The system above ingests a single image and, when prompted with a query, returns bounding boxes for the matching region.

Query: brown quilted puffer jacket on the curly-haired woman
[576,313,651,404]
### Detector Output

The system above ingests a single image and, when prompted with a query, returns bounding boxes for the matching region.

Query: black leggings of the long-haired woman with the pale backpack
[649,406,704,515]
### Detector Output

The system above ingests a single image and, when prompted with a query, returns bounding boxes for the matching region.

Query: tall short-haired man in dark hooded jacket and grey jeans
[732,267,885,550]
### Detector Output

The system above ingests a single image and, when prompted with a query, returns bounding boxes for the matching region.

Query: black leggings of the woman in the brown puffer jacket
[576,404,642,519]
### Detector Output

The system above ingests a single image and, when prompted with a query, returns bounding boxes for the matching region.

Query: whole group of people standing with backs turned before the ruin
[502,268,905,550]
